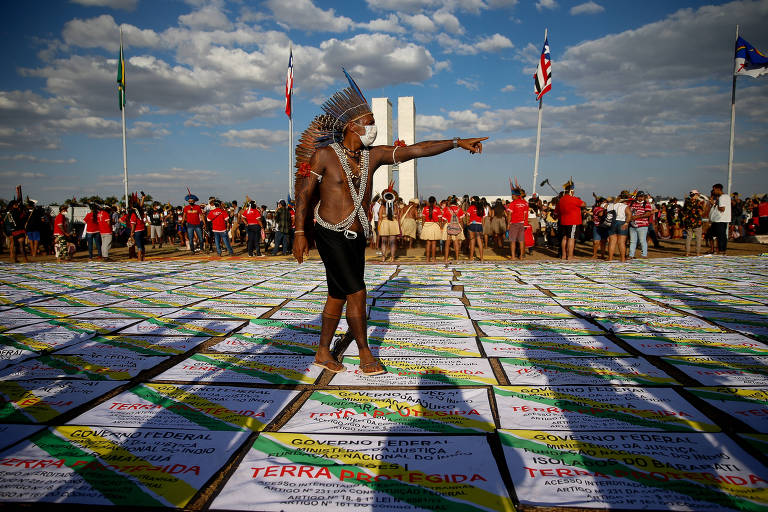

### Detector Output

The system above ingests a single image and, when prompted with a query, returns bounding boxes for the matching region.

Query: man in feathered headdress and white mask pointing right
[293,72,487,375]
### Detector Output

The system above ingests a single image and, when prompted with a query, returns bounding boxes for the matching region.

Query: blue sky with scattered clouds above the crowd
[0,0,768,203]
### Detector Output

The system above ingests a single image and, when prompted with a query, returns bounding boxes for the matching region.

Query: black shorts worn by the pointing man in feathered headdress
[314,224,368,299]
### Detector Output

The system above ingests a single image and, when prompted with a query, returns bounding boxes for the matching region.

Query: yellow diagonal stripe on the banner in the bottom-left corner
[54,427,198,507]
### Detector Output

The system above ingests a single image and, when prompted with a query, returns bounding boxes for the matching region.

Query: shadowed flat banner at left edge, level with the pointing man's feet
[0,353,166,380]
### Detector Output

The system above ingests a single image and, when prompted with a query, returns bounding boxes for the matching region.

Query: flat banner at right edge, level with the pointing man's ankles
[619,332,768,356]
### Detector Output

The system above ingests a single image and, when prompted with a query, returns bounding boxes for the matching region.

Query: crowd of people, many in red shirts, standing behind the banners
[2,181,768,262]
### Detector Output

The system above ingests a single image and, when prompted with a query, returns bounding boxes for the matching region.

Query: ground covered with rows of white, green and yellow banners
[0,254,768,511]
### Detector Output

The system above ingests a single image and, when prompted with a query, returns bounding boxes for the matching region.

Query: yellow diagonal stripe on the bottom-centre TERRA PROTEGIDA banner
[262,433,515,512]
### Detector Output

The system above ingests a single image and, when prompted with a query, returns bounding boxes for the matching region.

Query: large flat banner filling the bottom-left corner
[0,426,248,508]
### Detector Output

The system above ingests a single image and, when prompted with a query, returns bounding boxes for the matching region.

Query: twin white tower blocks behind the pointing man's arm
[371,96,419,203]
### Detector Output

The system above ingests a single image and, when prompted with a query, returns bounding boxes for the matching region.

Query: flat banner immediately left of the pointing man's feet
[154,354,322,384]
